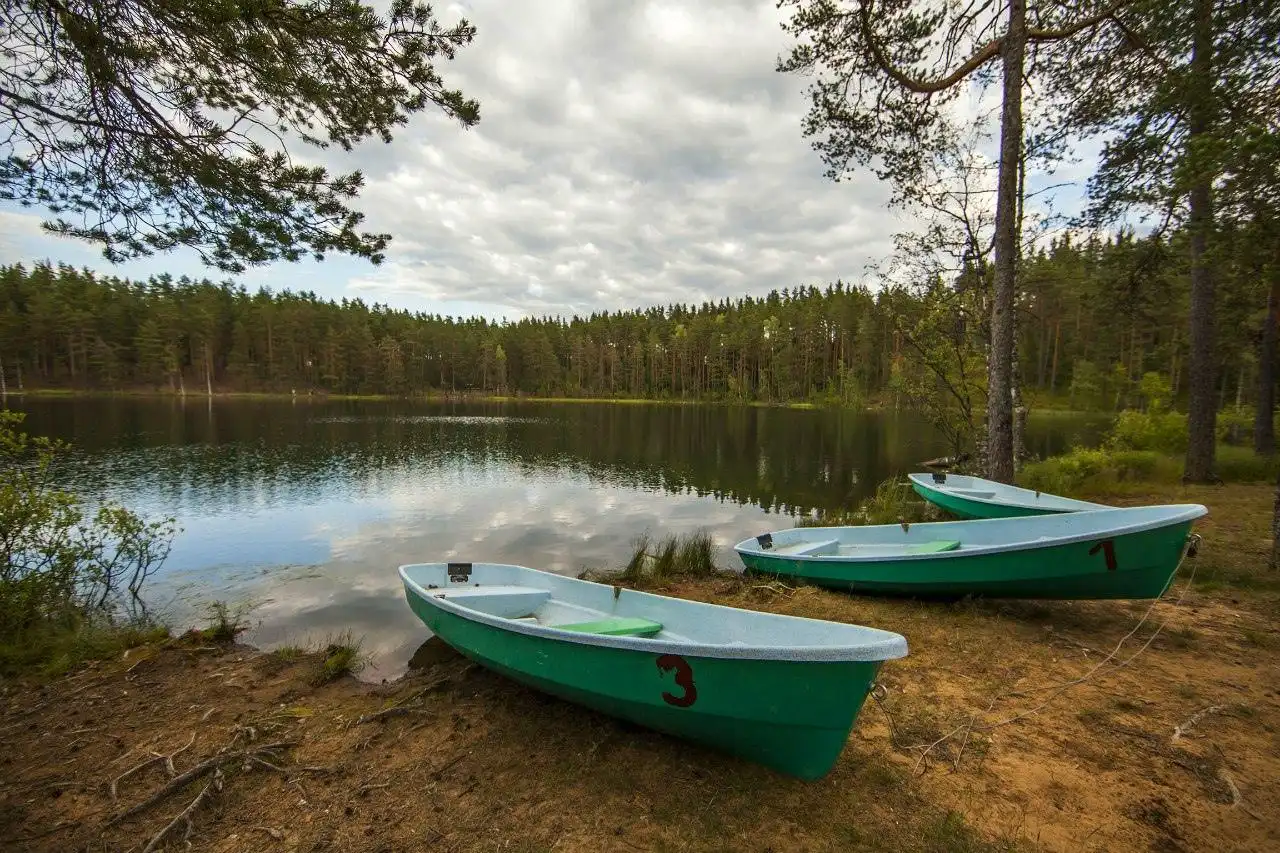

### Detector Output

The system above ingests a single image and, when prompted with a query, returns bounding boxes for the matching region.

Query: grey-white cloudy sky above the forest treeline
[0,0,1090,318]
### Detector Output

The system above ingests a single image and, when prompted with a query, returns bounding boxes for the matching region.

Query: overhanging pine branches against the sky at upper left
[0,0,480,272]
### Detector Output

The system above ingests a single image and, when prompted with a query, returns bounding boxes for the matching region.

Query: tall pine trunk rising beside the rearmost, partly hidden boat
[987,0,1027,483]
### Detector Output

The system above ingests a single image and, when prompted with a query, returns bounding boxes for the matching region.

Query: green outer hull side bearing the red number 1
[739,512,1192,599]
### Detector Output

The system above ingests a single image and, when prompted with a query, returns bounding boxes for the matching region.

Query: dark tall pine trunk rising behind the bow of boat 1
[1183,0,1217,483]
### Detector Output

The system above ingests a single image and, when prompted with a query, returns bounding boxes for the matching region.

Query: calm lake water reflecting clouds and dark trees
[9,397,1098,679]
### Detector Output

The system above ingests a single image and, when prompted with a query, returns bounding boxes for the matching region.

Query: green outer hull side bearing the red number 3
[406,588,883,779]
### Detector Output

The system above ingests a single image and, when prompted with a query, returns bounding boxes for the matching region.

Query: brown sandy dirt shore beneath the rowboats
[0,485,1280,853]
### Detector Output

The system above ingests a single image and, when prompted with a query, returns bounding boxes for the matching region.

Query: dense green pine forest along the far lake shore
[0,224,1267,409]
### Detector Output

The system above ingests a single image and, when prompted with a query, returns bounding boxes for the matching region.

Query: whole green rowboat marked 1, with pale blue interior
[735,503,1207,598]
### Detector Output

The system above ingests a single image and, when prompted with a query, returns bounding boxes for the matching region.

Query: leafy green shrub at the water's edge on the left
[0,411,174,644]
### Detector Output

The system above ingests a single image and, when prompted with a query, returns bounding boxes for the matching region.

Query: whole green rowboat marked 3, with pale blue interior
[399,562,906,779]
